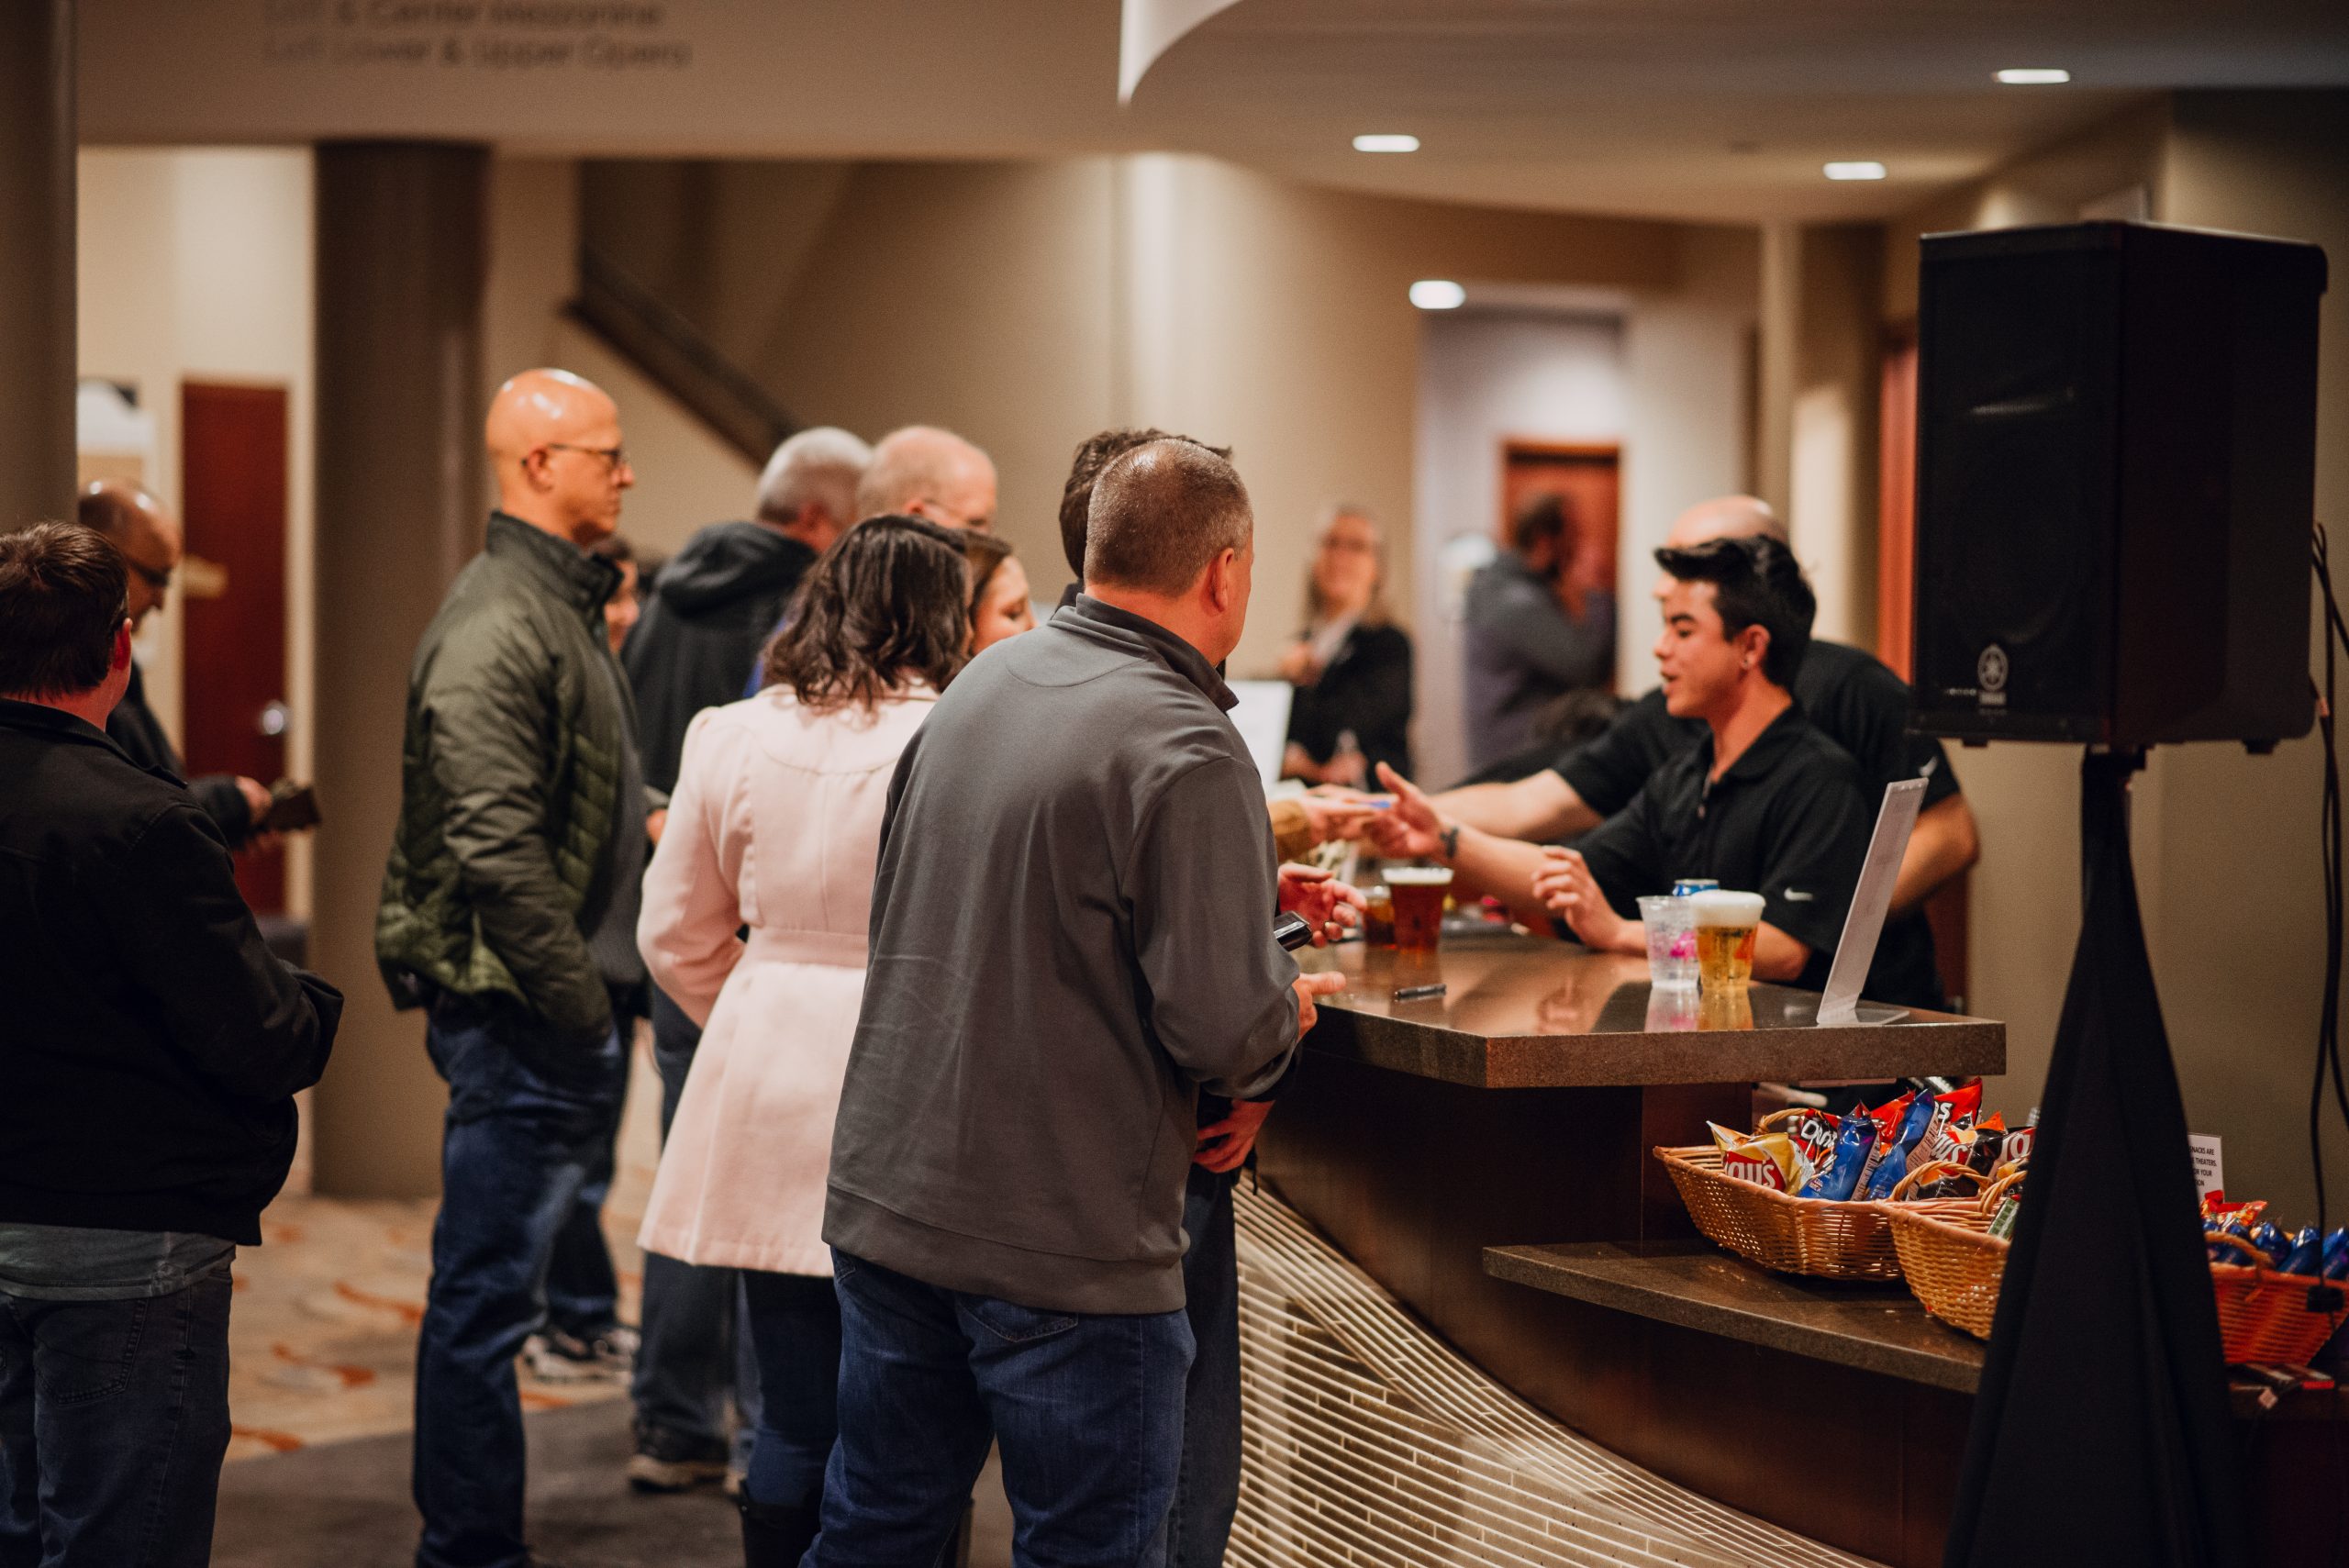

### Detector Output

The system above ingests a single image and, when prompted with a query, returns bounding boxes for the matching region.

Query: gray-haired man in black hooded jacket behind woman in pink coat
[620,425,874,1491]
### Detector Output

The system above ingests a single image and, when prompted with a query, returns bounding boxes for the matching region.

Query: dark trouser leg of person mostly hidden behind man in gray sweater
[1167,1164,1241,1568]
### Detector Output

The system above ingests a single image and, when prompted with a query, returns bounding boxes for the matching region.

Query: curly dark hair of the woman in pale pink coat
[761,512,970,711]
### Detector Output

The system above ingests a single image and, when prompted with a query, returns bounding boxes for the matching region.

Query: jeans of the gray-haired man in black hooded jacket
[629,986,756,1470]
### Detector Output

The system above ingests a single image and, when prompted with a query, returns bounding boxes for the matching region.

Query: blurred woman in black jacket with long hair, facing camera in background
[1280,507,1412,784]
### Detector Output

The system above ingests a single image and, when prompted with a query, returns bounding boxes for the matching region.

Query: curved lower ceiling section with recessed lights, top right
[1130,0,2349,220]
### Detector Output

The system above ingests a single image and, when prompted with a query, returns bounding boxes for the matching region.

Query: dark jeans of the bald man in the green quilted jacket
[414,997,628,1568]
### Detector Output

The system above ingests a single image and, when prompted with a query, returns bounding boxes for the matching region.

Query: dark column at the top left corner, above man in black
[0,0,75,528]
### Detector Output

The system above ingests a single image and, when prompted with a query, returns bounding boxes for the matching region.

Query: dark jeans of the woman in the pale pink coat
[742,1268,841,1507]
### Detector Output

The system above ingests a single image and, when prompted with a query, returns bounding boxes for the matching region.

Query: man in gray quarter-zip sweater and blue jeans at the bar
[808,441,1339,1568]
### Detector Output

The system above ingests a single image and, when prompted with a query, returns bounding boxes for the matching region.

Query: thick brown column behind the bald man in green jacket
[310,143,488,1197]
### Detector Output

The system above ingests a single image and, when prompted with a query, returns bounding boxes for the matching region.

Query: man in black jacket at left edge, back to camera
[0,524,343,1568]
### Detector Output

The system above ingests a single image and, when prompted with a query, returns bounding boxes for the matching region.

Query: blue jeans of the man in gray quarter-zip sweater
[806,1249,1191,1568]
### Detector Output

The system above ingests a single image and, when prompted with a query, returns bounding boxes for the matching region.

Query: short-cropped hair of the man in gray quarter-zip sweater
[1085,437,1257,596]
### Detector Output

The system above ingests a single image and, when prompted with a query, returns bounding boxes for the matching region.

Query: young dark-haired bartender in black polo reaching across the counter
[1376,539,1872,988]
